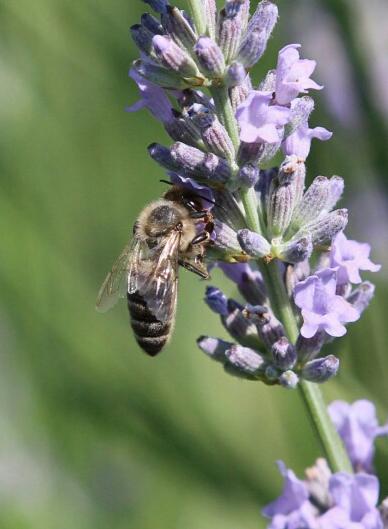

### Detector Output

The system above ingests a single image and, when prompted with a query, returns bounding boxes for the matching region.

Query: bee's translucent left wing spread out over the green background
[96,237,142,312]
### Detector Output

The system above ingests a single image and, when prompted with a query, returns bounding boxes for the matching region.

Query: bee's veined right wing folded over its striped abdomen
[137,231,181,322]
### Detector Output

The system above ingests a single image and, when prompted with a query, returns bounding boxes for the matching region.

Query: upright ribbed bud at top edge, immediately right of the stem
[217,7,243,64]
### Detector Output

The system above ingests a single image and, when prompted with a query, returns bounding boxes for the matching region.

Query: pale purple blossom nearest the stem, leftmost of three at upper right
[236,90,291,143]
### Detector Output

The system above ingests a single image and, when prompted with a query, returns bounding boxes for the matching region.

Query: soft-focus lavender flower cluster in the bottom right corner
[262,400,388,529]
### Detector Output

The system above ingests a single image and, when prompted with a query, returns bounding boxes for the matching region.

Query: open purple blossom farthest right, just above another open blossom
[330,232,381,285]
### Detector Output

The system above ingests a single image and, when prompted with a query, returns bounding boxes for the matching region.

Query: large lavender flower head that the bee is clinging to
[128,0,379,388]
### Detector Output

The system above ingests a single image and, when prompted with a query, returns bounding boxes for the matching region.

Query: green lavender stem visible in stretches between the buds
[211,81,352,472]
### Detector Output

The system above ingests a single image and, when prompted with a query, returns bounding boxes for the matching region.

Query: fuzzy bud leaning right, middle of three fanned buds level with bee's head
[292,176,330,228]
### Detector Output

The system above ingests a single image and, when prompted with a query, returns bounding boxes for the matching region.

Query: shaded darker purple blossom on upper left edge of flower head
[126,68,174,124]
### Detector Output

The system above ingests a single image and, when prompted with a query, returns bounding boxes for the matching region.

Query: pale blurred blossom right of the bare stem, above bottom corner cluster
[328,400,388,472]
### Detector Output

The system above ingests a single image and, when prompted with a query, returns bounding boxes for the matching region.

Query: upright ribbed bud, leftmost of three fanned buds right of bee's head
[267,172,296,237]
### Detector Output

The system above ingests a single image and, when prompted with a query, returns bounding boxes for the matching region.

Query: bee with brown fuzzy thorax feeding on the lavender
[96,185,213,356]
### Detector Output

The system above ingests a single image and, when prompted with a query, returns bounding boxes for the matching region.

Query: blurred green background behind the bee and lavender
[0,0,388,529]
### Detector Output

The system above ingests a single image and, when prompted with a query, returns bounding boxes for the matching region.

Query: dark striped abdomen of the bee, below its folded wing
[127,292,171,356]
